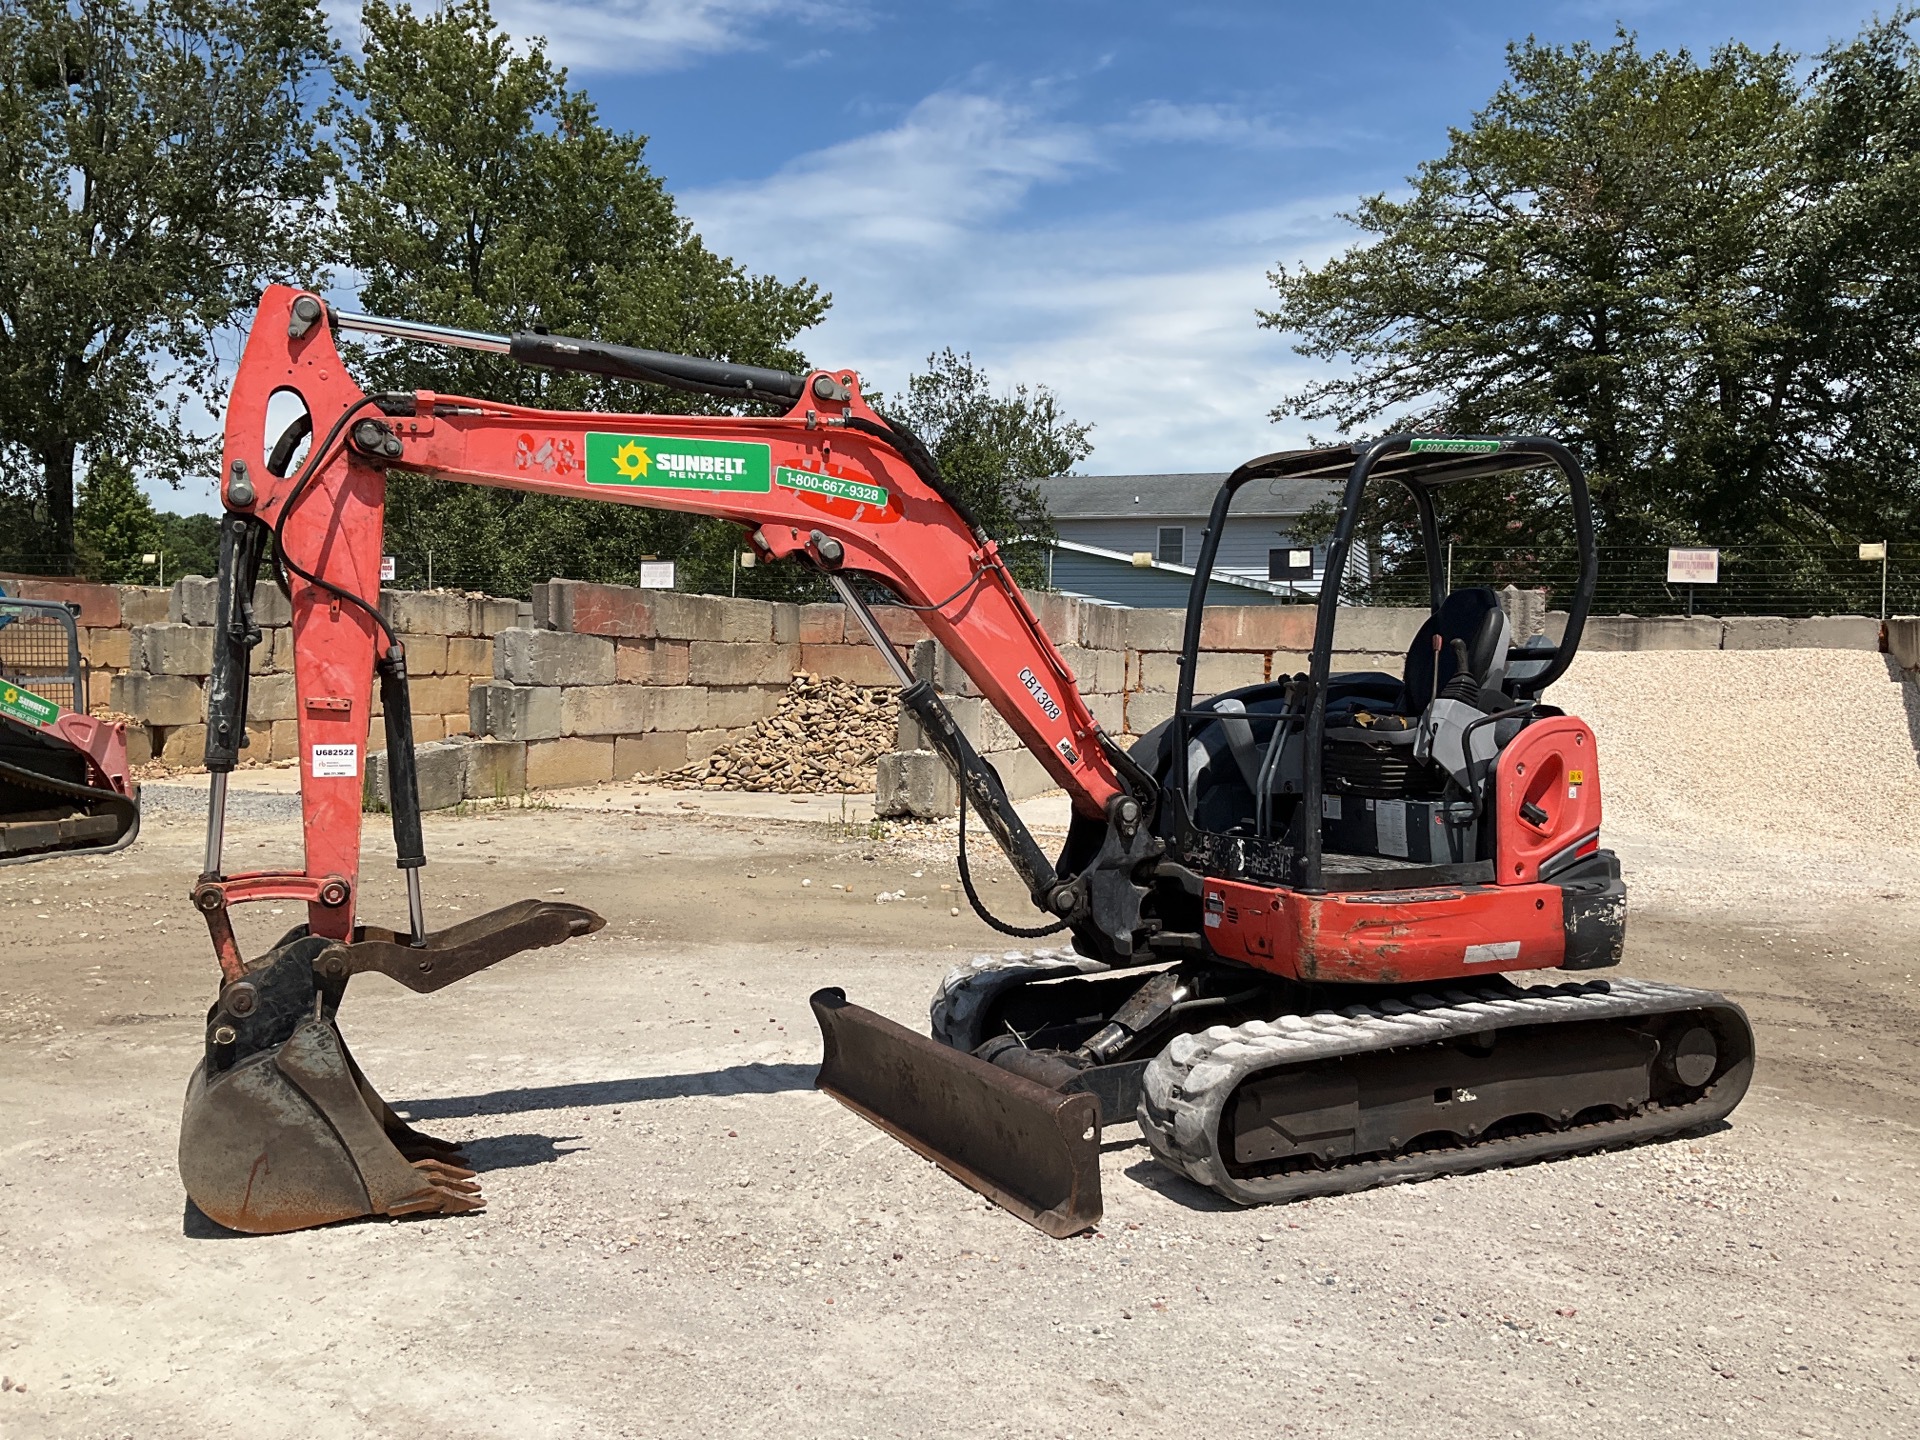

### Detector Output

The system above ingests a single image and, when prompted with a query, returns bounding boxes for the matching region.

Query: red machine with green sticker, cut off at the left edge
[0,595,140,864]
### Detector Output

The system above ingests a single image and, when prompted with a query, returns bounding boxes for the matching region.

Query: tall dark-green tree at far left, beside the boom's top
[0,0,332,568]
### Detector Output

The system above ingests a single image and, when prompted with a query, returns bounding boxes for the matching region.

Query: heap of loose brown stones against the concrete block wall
[634,674,899,795]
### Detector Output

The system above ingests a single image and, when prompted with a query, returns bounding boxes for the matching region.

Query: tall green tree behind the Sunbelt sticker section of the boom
[338,0,828,593]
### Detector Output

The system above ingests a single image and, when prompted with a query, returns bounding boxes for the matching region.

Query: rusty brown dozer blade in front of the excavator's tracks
[812,989,1100,1240]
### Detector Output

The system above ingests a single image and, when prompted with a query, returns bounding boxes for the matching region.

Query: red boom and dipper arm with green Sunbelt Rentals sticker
[204,286,1129,941]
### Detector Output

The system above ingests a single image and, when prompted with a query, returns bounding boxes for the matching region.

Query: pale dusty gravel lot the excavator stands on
[0,779,1920,1440]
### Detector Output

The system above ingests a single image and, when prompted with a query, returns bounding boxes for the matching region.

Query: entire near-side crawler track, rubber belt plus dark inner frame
[1139,979,1753,1206]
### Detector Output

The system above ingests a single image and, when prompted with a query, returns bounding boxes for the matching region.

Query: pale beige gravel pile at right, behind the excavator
[1548,651,1920,851]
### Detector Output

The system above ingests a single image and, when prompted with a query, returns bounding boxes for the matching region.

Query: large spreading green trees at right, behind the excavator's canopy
[1261,13,1920,599]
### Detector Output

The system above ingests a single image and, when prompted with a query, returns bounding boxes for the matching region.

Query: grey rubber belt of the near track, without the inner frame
[1139,979,1753,1206]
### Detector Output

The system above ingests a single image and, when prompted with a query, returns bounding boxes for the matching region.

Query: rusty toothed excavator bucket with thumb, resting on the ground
[180,900,605,1235]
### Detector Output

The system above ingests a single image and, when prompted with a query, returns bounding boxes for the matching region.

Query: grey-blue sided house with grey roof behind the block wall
[1041,472,1338,605]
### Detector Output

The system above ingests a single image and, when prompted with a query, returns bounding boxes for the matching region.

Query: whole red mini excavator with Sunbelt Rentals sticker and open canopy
[180,288,1753,1236]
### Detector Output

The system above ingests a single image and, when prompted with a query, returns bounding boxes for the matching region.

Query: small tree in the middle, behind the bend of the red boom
[876,349,1092,584]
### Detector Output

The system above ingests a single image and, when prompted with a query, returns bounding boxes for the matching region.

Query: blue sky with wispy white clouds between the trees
[163,0,1874,518]
